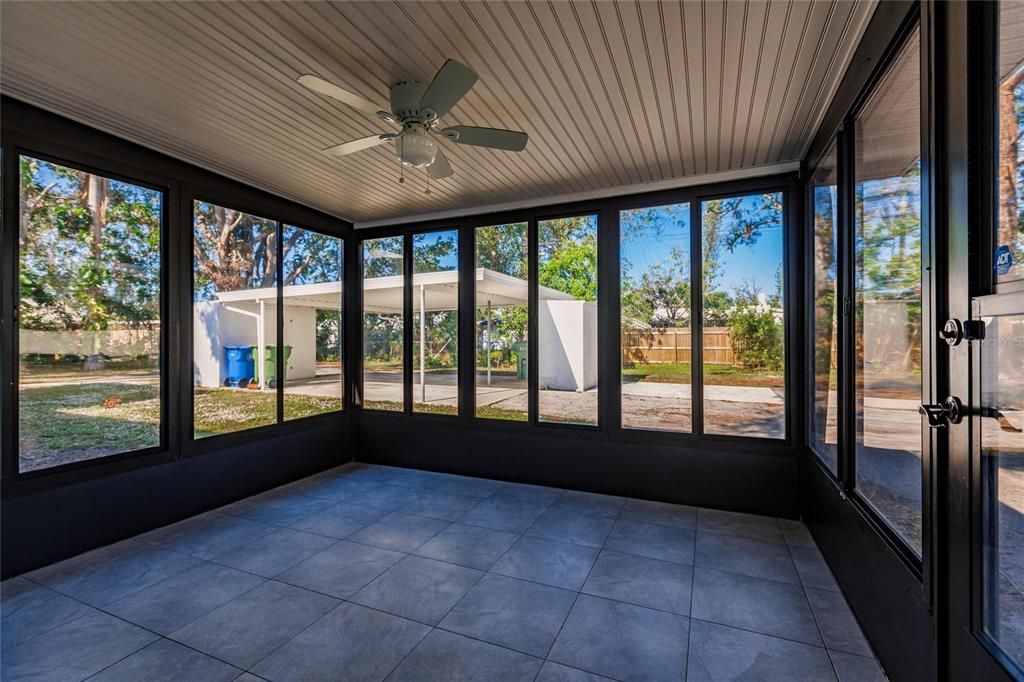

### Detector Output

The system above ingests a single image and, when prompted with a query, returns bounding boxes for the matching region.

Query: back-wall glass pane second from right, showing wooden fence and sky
[618,204,693,432]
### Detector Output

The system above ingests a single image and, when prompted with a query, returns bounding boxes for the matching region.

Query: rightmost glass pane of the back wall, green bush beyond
[701,194,785,438]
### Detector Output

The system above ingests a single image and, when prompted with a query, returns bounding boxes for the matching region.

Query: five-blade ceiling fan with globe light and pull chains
[298,59,528,179]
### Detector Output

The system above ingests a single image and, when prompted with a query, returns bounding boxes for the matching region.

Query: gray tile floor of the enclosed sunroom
[0,464,885,682]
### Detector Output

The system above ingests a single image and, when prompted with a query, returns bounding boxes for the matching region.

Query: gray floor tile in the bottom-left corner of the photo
[3,610,157,682]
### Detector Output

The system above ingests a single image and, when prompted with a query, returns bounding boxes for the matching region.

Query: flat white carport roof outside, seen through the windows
[217,267,575,312]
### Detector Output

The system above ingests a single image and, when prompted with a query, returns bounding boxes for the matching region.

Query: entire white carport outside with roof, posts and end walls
[194,267,597,399]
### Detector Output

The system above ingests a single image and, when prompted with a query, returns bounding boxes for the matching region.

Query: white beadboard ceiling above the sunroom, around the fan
[0,0,874,223]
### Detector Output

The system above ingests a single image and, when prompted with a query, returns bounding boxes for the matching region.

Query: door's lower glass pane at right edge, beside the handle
[980,314,1024,662]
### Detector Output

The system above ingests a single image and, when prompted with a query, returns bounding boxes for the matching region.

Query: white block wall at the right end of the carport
[538,301,597,391]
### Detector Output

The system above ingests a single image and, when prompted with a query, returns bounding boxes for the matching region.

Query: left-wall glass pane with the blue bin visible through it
[193,201,278,438]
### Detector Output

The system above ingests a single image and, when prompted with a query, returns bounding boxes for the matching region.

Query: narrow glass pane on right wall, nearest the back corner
[811,145,839,473]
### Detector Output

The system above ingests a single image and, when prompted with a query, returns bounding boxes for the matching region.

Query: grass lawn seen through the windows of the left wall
[18,382,341,469]
